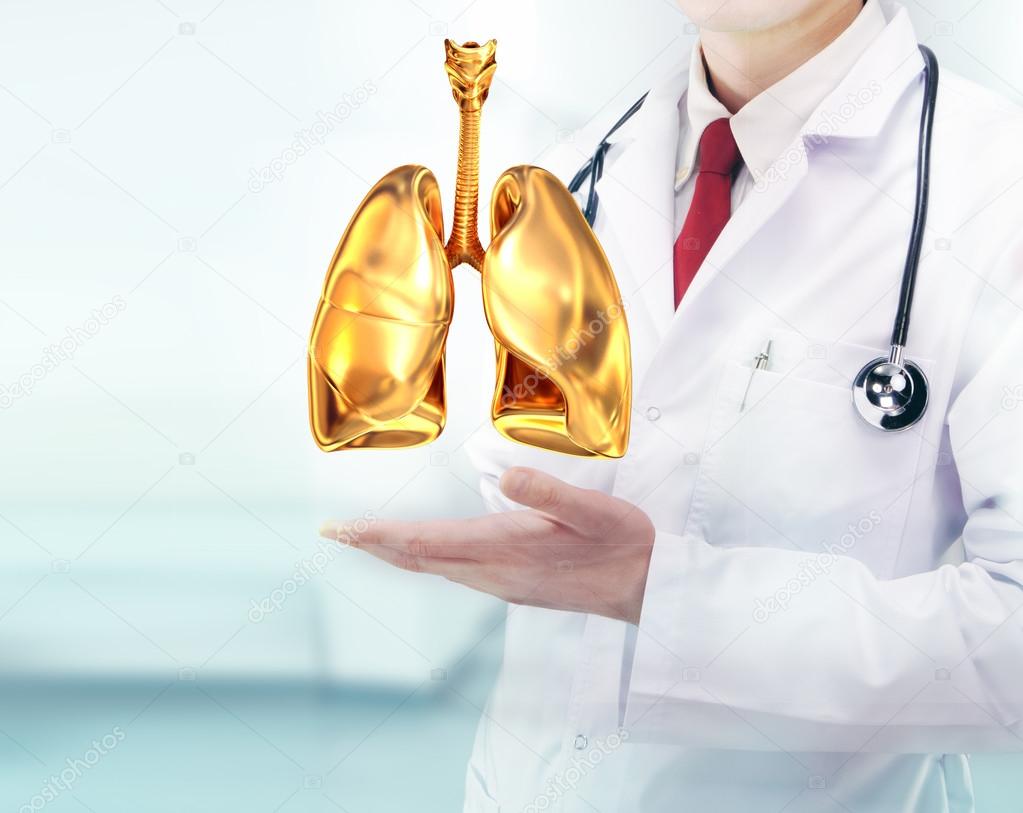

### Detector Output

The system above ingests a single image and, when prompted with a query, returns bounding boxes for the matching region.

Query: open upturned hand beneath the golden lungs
[320,468,655,624]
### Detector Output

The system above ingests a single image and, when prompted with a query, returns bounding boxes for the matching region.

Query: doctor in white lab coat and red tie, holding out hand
[324,0,1023,813]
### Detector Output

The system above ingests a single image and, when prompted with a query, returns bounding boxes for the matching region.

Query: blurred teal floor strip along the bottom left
[0,681,488,813]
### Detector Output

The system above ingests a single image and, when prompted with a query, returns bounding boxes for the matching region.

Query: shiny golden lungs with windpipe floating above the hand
[309,40,632,457]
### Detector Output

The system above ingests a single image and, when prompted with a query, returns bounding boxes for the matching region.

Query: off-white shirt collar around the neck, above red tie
[675,0,887,189]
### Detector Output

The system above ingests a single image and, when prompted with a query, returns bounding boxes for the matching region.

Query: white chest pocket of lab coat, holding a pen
[688,351,922,576]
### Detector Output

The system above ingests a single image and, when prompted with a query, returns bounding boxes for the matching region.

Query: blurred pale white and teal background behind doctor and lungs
[0,0,1023,813]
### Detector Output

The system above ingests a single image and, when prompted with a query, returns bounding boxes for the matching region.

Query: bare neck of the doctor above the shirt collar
[700,0,863,114]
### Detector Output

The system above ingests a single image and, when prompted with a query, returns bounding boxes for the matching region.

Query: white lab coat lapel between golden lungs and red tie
[596,66,688,338]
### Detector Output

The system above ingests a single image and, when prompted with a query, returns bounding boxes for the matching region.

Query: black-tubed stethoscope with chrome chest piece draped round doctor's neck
[569,45,938,432]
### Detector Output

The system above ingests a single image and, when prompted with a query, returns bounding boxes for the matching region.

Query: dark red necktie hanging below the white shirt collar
[674,119,743,308]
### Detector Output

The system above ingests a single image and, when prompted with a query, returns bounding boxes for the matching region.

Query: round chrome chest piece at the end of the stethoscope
[852,356,928,432]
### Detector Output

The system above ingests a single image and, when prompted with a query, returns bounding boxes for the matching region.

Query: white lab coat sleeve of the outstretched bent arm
[625,257,1023,753]
